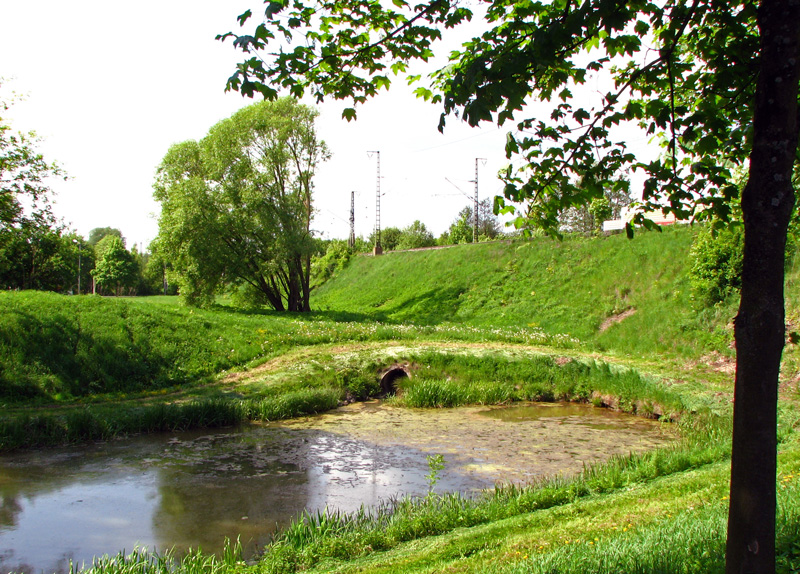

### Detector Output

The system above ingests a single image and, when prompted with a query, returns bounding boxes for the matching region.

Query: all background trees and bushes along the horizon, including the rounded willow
[0,82,618,311]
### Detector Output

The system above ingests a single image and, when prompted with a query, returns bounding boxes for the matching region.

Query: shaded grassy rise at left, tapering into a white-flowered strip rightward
[0,292,577,406]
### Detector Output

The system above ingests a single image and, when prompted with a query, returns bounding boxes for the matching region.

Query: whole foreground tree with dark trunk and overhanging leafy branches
[217,0,800,573]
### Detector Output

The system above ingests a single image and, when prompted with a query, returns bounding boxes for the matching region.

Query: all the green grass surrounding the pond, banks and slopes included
[0,228,800,574]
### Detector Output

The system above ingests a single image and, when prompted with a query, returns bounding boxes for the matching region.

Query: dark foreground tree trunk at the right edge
[726,0,800,574]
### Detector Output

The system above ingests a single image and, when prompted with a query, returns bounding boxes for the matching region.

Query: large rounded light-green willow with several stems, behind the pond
[154,98,328,311]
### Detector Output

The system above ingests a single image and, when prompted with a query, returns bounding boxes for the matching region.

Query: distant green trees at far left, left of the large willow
[0,85,163,295]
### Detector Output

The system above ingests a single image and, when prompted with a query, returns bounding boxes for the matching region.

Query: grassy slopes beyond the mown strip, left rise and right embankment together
[6,227,800,404]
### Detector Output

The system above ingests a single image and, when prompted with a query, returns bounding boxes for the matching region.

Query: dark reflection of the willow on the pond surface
[153,429,314,552]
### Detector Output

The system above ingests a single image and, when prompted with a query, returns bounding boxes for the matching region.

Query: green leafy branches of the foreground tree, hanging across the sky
[219,0,759,233]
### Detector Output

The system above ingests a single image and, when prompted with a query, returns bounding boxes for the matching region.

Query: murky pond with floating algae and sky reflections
[0,401,671,574]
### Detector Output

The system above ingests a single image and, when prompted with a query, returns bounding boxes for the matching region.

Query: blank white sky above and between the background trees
[0,0,656,247]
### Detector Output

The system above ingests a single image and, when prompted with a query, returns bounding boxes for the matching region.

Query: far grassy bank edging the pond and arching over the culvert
[0,342,688,452]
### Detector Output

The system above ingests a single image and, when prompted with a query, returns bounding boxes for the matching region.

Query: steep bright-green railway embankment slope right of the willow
[312,227,735,356]
